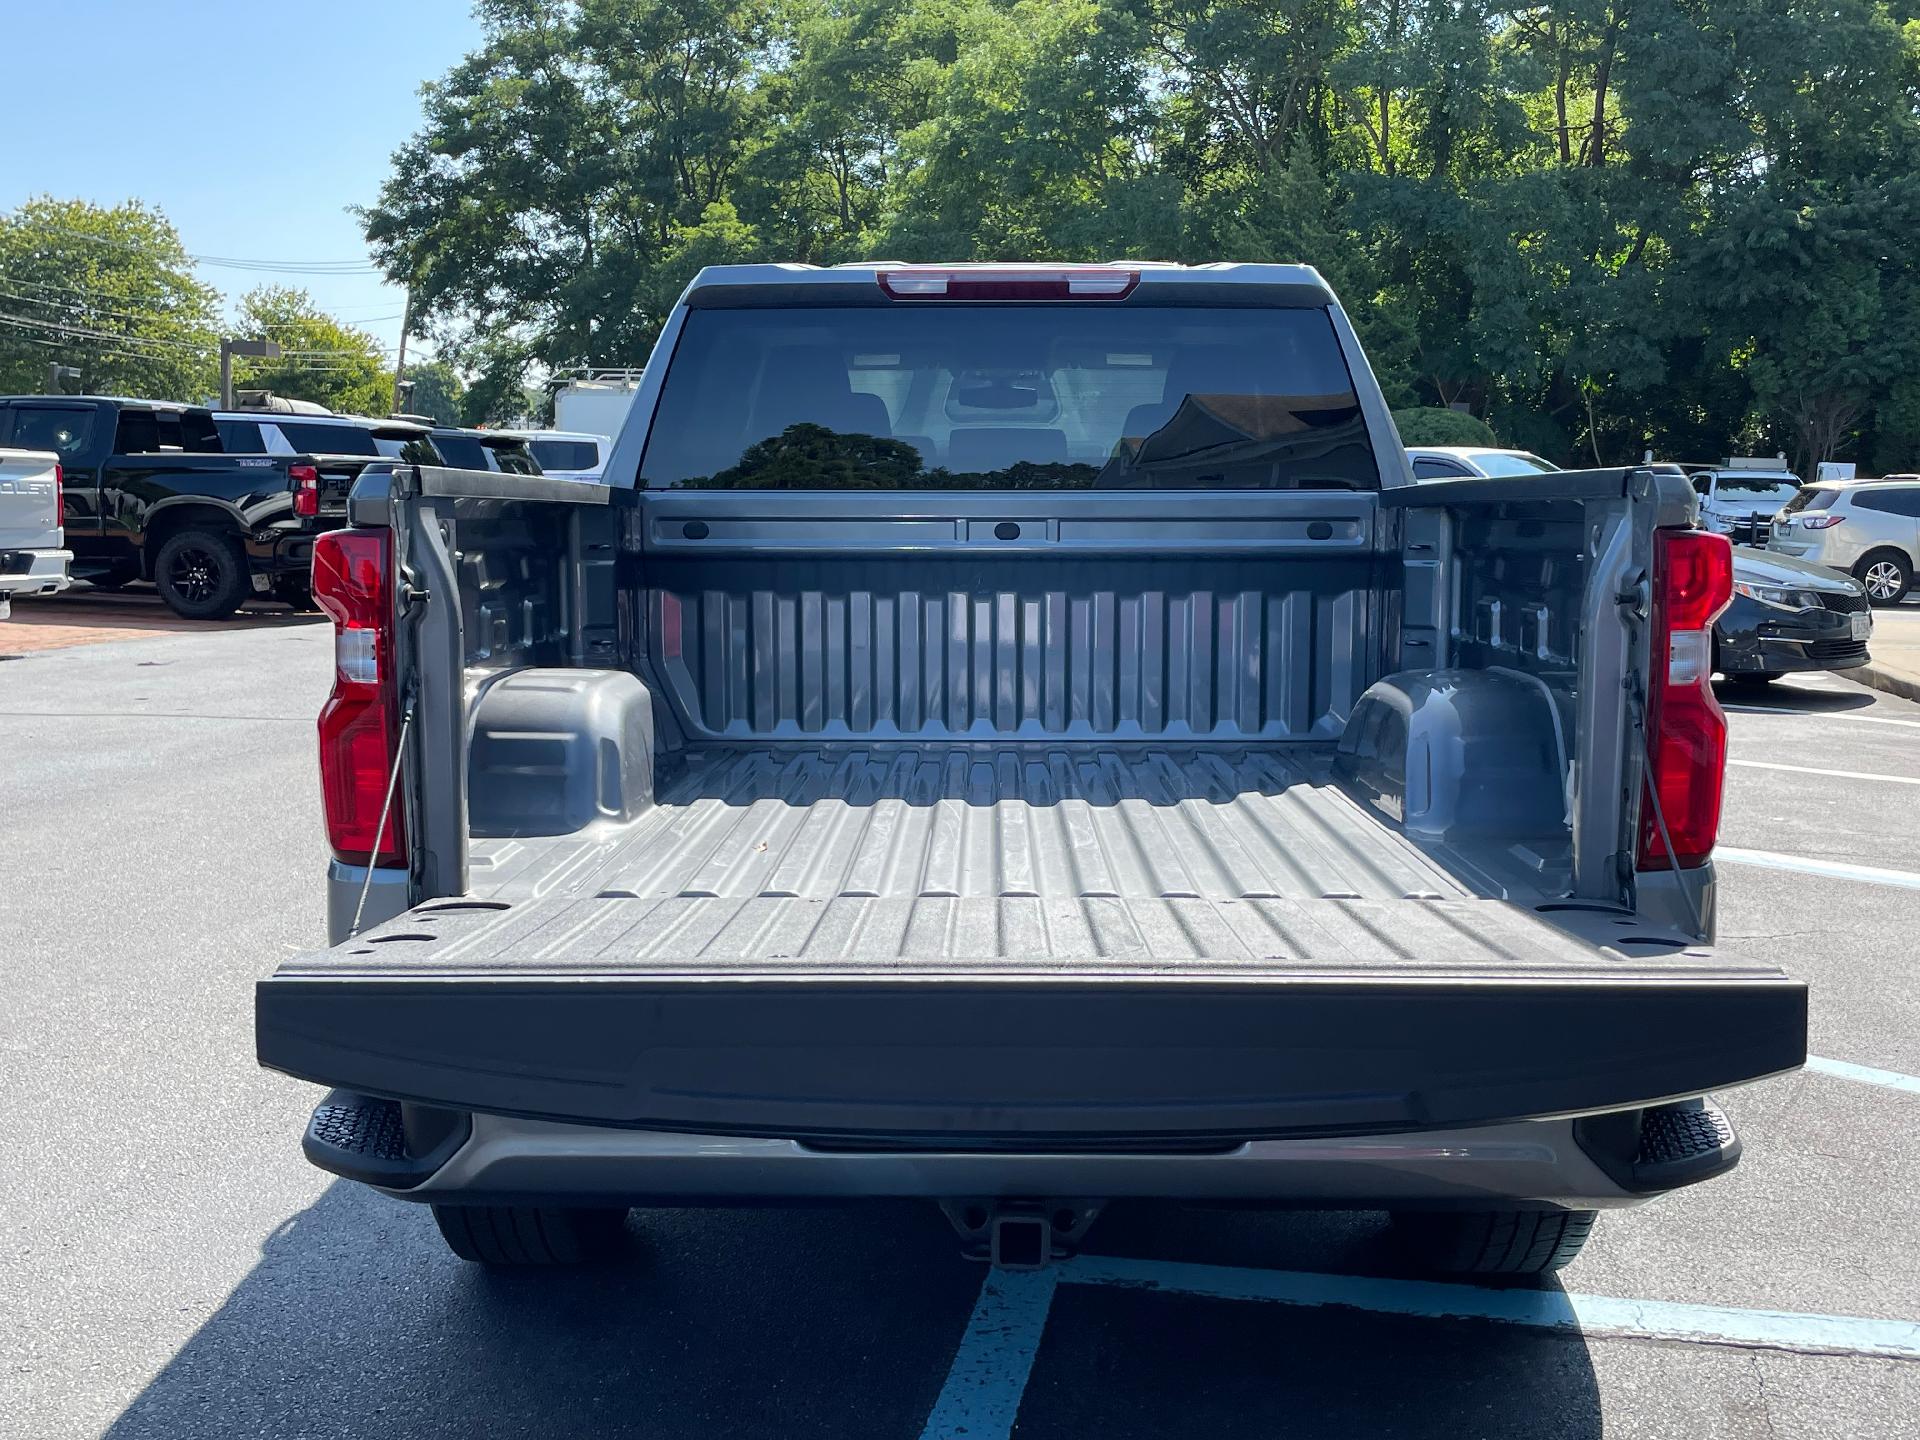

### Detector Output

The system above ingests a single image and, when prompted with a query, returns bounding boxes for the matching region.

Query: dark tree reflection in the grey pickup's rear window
[676,422,1096,490]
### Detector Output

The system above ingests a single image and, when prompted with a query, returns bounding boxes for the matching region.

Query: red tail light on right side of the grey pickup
[1638,530,1734,870]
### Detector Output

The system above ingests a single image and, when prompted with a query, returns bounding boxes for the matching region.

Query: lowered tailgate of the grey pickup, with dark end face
[257,895,1807,1144]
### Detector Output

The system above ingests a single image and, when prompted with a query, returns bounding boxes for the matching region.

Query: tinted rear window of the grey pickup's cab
[641,301,1379,490]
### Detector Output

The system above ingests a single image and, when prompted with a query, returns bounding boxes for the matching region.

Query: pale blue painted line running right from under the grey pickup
[1060,1256,1920,1359]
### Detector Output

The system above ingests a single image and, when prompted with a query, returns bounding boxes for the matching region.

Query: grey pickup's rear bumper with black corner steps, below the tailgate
[305,1092,1740,1210]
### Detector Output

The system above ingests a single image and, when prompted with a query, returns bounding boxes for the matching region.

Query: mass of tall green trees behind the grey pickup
[365,0,1920,467]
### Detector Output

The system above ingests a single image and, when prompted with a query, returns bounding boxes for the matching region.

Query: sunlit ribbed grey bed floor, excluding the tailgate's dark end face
[311,747,1666,972]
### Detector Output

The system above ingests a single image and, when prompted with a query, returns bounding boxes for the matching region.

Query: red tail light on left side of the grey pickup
[313,530,407,864]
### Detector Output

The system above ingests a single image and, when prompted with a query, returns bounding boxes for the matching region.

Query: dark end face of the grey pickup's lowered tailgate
[255,963,1807,1150]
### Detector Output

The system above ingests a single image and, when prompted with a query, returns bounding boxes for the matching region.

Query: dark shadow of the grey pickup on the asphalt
[108,1183,1599,1440]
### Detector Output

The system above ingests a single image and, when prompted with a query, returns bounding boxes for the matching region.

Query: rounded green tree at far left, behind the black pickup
[0,196,219,401]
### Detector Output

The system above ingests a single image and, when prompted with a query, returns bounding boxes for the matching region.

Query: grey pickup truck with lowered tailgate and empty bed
[255,265,1807,1273]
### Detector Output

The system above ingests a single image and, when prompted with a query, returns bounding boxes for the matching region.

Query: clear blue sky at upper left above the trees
[0,0,480,359]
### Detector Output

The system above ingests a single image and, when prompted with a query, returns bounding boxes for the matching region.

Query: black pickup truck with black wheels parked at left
[0,396,365,620]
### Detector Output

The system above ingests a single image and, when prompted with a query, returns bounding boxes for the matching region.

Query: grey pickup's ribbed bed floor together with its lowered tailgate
[257,745,1805,1146]
